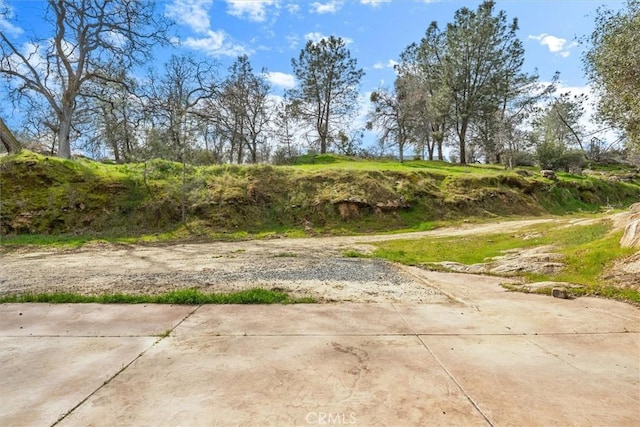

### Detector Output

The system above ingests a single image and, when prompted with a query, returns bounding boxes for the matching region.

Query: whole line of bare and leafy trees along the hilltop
[0,0,640,168]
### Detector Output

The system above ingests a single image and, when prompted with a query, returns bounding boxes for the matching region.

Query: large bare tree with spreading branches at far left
[0,0,167,158]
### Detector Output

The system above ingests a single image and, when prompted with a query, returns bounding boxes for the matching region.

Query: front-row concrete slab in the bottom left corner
[0,336,157,426]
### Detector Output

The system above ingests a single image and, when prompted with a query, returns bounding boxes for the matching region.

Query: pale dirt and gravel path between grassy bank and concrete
[0,219,553,303]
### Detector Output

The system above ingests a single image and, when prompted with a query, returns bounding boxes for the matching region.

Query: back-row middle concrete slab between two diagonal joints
[174,303,412,336]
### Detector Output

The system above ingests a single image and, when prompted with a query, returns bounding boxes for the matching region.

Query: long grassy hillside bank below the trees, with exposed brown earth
[0,152,640,241]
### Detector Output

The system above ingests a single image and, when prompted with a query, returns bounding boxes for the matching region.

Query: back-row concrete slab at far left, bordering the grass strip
[0,304,197,337]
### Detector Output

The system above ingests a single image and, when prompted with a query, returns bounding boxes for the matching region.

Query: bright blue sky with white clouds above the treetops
[0,0,623,150]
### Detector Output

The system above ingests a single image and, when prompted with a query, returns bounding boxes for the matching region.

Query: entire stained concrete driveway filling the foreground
[0,269,640,426]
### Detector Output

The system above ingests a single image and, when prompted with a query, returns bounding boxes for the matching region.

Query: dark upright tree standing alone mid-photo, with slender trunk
[289,36,364,153]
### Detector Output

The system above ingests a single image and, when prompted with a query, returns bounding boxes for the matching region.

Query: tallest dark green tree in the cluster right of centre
[443,0,524,164]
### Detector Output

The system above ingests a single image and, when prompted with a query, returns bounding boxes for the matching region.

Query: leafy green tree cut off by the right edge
[583,0,640,148]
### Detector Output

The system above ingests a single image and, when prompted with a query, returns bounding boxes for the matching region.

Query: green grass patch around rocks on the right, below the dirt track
[374,220,640,303]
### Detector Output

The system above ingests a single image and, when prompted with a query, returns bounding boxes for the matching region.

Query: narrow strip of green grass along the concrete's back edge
[0,288,316,305]
